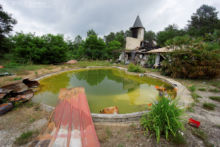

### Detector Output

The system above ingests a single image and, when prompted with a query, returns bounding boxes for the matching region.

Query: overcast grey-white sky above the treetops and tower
[0,0,220,38]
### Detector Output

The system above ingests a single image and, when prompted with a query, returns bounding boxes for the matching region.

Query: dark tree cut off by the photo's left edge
[0,5,16,56]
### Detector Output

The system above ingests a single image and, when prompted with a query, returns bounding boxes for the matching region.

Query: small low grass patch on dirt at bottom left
[14,131,38,145]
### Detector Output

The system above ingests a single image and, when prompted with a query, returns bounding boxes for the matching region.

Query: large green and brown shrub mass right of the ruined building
[162,36,220,79]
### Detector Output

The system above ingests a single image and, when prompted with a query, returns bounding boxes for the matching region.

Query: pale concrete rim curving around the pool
[35,66,194,122]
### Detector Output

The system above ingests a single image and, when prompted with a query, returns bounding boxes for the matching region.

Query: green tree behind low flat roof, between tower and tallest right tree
[156,24,185,46]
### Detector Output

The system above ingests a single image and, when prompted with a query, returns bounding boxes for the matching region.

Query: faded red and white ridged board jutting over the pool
[31,87,100,147]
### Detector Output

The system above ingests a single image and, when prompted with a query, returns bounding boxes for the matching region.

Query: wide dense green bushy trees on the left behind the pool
[12,33,67,64]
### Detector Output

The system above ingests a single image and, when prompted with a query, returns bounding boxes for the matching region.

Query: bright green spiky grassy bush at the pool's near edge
[141,97,184,142]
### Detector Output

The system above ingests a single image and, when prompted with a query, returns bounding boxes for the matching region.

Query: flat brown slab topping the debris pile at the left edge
[0,83,28,94]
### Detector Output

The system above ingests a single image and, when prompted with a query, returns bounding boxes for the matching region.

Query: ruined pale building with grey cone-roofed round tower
[119,16,168,67]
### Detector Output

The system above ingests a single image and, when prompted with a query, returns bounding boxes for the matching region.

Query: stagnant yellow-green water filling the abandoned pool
[32,68,175,113]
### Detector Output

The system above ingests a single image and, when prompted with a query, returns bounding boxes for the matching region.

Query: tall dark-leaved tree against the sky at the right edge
[188,5,220,36]
